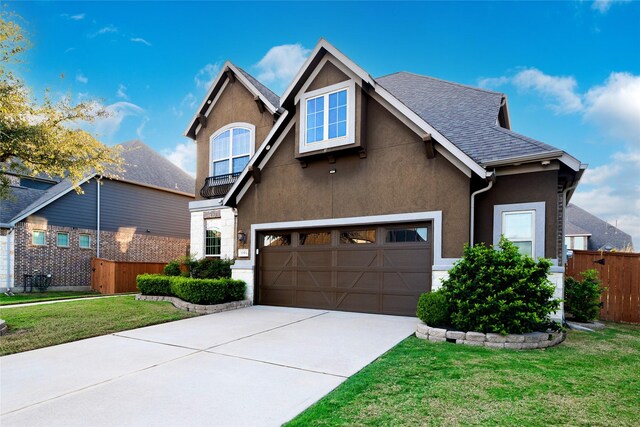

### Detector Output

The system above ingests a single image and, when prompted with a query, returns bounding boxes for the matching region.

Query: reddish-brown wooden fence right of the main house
[566,251,640,323]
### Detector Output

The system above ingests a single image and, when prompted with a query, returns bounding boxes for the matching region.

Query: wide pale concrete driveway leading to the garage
[0,306,417,427]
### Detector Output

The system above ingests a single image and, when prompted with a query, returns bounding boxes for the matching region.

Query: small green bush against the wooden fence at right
[564,269,605,322]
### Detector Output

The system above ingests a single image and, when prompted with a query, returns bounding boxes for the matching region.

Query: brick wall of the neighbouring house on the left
[14,222,189,290]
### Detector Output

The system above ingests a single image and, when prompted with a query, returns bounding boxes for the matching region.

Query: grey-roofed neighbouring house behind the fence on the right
[564,204,633,252]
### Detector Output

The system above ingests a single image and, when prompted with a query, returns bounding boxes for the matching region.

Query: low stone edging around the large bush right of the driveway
[416,322,566,350]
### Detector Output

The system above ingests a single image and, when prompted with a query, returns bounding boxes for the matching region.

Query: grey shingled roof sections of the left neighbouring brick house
[0,140,195,224]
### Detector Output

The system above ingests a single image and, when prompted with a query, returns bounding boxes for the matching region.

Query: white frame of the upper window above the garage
[298,80,356,153]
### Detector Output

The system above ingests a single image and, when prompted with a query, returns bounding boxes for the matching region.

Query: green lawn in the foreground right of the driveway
[287,324,640,426]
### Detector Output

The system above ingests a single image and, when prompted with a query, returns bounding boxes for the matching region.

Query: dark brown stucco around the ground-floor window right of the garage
[474,170,558,258]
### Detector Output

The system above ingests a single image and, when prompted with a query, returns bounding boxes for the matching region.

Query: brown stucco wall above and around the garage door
[238,99,470,258]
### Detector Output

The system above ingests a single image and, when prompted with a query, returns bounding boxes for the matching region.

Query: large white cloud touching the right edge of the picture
[584,73,640,148]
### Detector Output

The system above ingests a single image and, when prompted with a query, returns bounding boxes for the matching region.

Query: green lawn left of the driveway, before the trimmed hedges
[0,296,197,355]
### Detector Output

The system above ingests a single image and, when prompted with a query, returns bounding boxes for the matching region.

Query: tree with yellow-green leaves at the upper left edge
[0,9,121,200]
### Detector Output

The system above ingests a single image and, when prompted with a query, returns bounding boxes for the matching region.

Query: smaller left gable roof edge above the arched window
[184,61,282,139]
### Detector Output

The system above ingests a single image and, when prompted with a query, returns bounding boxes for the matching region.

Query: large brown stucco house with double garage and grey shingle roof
[185,40,585,315]
